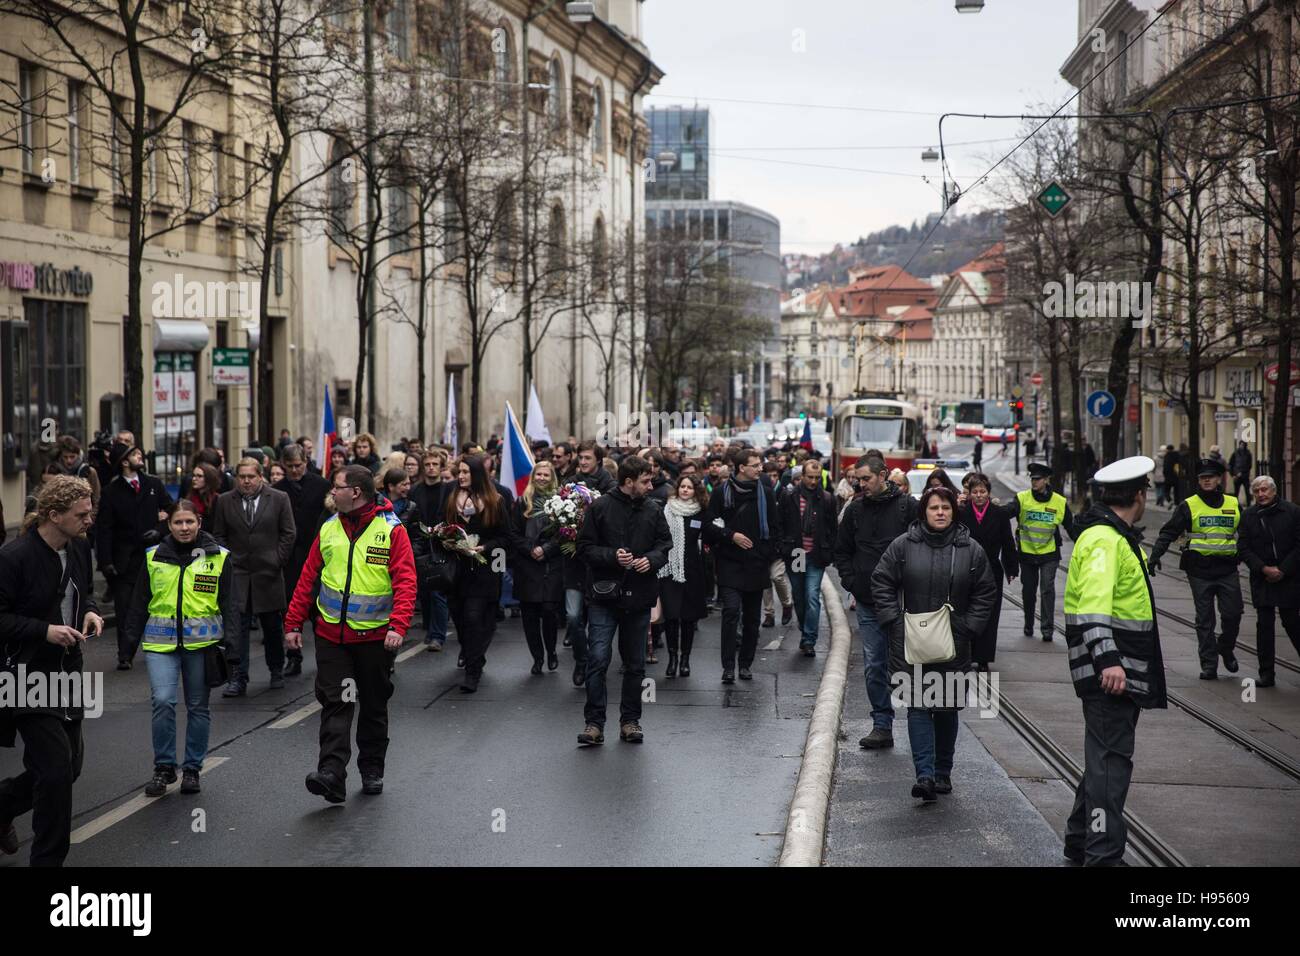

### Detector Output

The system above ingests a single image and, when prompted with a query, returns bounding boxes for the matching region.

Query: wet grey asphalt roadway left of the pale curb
[0,613,828,868]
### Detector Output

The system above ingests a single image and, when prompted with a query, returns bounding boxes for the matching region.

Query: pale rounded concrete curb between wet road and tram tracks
[777,575,853,866]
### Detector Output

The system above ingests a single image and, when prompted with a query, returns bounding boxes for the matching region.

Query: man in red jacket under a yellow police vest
[285,464,416,804]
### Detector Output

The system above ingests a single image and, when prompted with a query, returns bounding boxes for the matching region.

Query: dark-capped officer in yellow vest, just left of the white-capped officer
[1002,462,1075,641]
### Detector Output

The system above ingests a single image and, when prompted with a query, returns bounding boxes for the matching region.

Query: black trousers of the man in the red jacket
[316,630,393,780]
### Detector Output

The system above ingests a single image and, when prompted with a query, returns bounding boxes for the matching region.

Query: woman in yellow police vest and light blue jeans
[126,498,239,796]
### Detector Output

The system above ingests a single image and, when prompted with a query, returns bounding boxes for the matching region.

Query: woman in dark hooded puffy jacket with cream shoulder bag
[871,486,997,804]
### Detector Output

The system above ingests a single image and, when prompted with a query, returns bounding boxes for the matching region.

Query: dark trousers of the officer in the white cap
[1065,693,1141,866]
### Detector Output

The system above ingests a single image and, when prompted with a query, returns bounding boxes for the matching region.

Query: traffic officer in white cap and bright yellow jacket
[1065,455,1169,866]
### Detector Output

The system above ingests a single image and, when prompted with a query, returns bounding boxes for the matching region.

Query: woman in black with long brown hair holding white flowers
[443,455,515,693]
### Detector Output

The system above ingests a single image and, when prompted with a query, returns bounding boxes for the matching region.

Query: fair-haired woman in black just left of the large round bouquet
[510,460,564,674]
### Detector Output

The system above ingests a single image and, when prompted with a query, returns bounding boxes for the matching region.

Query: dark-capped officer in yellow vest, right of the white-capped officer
[1151,458,1244,680]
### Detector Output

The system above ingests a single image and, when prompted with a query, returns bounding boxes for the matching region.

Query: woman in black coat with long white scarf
[659,475,709,678]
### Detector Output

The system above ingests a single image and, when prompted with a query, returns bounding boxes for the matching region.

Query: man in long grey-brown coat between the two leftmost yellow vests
[212,458,296,697]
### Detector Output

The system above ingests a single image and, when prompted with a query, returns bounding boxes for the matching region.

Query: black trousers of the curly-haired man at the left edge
[0,714,86,866]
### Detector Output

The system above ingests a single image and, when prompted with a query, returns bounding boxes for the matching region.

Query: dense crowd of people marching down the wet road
[0,431,1300,865]
